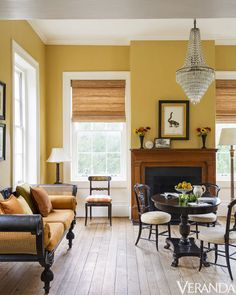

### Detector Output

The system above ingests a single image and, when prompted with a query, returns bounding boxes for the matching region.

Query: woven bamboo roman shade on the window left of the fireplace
[71,80,125,122]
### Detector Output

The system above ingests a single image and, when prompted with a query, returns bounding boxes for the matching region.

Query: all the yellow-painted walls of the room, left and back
[0,21,224,186]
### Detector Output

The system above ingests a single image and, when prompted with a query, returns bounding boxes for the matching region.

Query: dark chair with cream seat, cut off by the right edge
[199,200,236,280]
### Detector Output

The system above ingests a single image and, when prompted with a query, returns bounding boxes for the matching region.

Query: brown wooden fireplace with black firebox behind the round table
[131,149,217,220]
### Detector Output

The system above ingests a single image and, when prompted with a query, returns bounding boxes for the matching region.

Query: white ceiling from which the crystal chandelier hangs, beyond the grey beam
[29,18,236,45]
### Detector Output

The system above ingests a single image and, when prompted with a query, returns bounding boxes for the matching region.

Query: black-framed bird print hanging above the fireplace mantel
[159,100,189,140]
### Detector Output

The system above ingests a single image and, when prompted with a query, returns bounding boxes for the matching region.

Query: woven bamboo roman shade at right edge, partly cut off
[216,80,236,123]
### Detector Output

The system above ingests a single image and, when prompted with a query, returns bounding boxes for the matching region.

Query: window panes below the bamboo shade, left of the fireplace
[72,122,126,180]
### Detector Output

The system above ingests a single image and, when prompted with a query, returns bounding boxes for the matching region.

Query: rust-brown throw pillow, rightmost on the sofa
[31,187,52,217]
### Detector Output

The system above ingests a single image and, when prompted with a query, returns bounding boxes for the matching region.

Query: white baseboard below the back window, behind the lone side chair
[76,202,130,217]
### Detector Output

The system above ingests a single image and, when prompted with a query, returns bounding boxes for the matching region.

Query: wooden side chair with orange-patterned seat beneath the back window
[85,176,112,226]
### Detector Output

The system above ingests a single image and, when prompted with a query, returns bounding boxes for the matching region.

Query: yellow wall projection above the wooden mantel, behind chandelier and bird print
[130,41,215,148]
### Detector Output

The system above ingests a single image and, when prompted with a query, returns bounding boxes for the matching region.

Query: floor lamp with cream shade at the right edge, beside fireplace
[219,128,236,201]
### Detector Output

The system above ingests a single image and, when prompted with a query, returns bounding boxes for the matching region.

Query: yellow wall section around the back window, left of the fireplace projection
[46,45,129,182]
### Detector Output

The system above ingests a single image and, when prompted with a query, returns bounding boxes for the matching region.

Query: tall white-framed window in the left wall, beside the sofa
[13,42,39,187]
